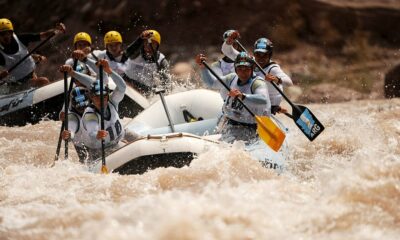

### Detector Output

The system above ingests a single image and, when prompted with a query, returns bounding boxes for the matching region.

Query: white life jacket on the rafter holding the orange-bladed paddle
[222,75,268,124]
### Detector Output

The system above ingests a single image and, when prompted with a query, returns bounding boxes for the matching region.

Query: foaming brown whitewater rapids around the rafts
[0,99,400,240]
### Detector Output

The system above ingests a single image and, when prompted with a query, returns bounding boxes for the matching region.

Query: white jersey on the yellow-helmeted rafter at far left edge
[0,33,35,82]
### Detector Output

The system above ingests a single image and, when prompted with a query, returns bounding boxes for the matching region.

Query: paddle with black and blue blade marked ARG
[235,39,325,141]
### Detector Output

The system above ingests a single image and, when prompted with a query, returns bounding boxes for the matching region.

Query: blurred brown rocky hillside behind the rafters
[0,0,400,101]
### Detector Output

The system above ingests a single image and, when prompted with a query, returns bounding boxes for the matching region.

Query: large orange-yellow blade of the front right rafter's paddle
[256,116,286,152]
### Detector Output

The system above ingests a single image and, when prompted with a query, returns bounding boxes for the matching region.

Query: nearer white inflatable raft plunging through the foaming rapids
[90,89,288,174]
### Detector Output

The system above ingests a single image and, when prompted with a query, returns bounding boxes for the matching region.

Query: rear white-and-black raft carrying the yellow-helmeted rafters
[0,79,150,126]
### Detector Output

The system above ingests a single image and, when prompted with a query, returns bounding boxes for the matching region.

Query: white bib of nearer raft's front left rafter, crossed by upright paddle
[82,102,125,149]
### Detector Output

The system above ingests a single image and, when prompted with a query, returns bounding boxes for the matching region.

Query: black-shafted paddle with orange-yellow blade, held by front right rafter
[201,60,285,152]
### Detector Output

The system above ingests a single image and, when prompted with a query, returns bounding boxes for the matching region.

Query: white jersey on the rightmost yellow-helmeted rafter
[125,53,165,87]
